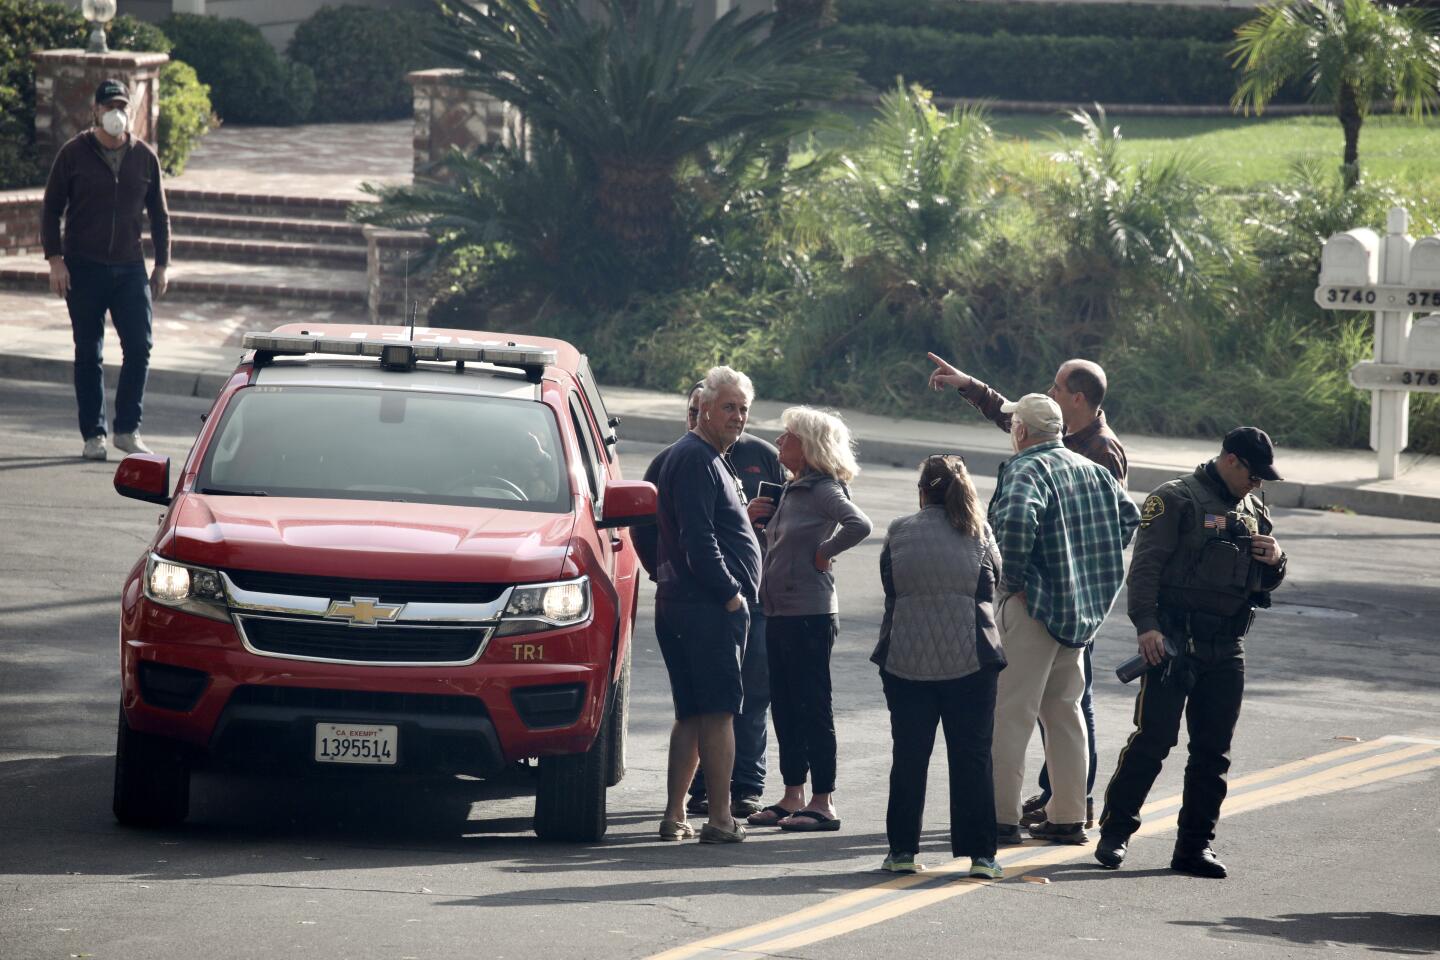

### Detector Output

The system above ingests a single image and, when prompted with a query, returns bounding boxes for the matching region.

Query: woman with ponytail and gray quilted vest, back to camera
[870,455,1005,879]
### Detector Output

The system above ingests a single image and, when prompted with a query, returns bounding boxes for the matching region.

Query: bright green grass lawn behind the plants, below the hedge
[825,108,1440,213]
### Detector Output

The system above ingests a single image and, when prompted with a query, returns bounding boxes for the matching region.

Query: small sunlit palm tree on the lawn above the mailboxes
[1230,0,1440,187]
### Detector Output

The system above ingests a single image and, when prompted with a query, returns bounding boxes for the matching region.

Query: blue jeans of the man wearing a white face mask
[65,258,153,440]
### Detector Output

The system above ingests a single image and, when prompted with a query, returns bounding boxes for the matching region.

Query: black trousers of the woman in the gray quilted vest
[880,669,998,856]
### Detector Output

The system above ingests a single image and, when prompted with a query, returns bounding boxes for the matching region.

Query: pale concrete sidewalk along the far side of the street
[0,303,1440,522]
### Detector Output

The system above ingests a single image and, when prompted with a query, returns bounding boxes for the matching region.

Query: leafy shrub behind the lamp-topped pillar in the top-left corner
[0,0,170,190]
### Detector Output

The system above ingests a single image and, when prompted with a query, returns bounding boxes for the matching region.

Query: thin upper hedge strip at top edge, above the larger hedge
[838,0,1254,43]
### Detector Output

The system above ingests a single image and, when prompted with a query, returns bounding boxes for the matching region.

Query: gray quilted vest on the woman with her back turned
[870,504,1005,681]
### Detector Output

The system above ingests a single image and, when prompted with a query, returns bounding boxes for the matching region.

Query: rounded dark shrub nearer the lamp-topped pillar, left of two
[160,13,315,125]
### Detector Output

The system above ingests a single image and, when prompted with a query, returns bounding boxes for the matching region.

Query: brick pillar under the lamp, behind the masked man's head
[30,50,170,166]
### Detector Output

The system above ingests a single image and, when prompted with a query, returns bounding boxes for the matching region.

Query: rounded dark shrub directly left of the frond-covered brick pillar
[288,7,436,121]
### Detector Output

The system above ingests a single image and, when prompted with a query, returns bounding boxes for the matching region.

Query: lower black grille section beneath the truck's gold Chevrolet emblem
[236,616,491,664]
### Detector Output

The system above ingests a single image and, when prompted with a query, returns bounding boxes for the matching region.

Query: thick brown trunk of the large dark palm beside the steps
[595,157,675,268]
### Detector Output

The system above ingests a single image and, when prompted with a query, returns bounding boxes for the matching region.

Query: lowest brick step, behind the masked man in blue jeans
[0,256,369,307]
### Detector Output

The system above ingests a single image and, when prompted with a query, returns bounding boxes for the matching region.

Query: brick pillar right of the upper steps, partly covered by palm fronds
[405,68,526,178]
